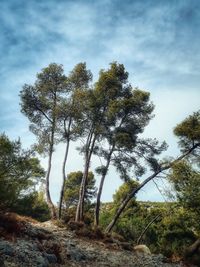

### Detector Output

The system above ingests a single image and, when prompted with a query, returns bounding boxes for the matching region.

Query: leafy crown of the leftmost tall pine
[20,63,68,154]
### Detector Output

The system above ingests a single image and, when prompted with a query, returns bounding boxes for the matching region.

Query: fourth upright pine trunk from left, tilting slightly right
[94,147,115,226]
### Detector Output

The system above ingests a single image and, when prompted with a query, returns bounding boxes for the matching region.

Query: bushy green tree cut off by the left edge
[0,134,44,209]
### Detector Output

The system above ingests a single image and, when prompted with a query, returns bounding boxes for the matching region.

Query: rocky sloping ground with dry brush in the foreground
[0,216,195,267]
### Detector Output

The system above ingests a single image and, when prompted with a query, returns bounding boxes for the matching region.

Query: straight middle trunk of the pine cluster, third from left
[75,133,96,222]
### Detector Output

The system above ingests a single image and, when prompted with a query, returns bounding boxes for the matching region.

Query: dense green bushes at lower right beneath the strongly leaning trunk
[100,202,200,257]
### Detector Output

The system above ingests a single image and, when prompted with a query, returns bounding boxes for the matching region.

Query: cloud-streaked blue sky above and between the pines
[0,0,200,203]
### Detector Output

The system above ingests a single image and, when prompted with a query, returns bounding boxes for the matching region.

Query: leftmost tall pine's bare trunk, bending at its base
[46,140,56,219]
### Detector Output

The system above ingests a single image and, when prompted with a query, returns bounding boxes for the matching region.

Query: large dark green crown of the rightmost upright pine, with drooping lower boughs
[96,66,166,180]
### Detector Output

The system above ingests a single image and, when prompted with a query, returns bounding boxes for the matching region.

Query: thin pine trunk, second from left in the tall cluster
[58,139,70,219]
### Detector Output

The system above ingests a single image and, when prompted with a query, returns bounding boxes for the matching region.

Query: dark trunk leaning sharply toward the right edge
[106,143,200,233]
